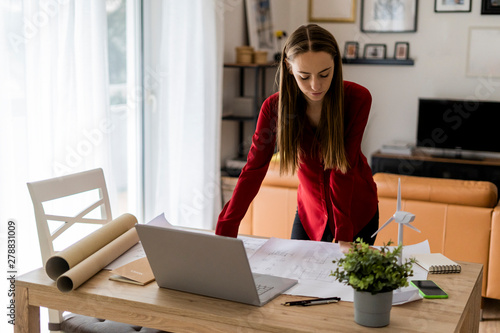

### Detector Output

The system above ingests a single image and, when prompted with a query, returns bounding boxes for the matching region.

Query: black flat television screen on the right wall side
[417,98,500,152]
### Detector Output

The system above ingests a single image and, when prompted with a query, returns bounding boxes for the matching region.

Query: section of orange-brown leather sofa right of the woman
[374,173,500,299]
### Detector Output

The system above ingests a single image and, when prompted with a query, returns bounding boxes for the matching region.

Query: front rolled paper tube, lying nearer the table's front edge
[56,228,139,292]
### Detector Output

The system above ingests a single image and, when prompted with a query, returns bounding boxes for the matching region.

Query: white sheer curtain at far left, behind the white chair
[0,0,113,274]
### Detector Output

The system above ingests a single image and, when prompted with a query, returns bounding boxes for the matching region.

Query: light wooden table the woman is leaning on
[15,262,483,333]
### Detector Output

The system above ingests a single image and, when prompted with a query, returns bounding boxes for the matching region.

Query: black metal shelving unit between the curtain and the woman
[222,63,276,159]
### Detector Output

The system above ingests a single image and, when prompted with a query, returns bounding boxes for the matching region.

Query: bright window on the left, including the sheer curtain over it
[0,0,142,273]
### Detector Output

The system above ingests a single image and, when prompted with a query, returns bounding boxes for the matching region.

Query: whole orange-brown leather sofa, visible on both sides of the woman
[239,161,500,299]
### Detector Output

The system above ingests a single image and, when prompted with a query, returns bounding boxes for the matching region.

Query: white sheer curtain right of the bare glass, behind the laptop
[146,0,223,229]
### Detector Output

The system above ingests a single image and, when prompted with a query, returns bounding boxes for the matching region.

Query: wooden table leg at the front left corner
[14,286,40,333]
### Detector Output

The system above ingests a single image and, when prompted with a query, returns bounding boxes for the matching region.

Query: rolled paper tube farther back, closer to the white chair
[45,214,137,281]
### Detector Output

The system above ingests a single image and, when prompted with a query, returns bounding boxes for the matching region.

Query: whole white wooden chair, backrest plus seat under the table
[27,168,166,333]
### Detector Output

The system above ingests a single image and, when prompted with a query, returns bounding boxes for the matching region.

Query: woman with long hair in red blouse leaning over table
[216,24,378,244]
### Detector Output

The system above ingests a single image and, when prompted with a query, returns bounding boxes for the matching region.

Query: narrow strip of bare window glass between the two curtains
[106,0,142,217]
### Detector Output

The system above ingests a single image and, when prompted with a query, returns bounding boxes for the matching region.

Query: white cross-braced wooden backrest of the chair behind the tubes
[27,168,112,266]
